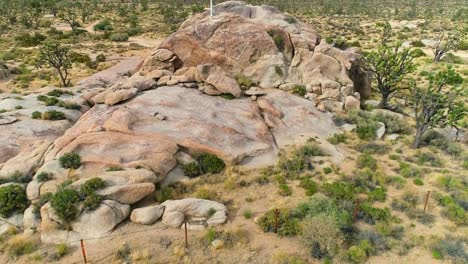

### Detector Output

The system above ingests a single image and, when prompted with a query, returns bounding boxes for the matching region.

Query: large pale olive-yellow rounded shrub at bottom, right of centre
[301,214,344,259]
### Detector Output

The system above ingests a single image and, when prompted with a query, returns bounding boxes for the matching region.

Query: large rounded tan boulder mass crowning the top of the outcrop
[141,1,370,106]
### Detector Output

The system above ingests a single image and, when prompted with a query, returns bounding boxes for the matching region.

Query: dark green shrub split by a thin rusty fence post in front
[258,209,300,236]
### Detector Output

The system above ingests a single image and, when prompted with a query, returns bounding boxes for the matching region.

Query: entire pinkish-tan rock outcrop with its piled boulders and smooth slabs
[0,1,370,243]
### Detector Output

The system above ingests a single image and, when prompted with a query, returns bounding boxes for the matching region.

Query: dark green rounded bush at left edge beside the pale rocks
[0,184,29,218]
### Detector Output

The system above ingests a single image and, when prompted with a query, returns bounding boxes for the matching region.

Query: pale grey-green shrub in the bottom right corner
[433,236,468,263]
